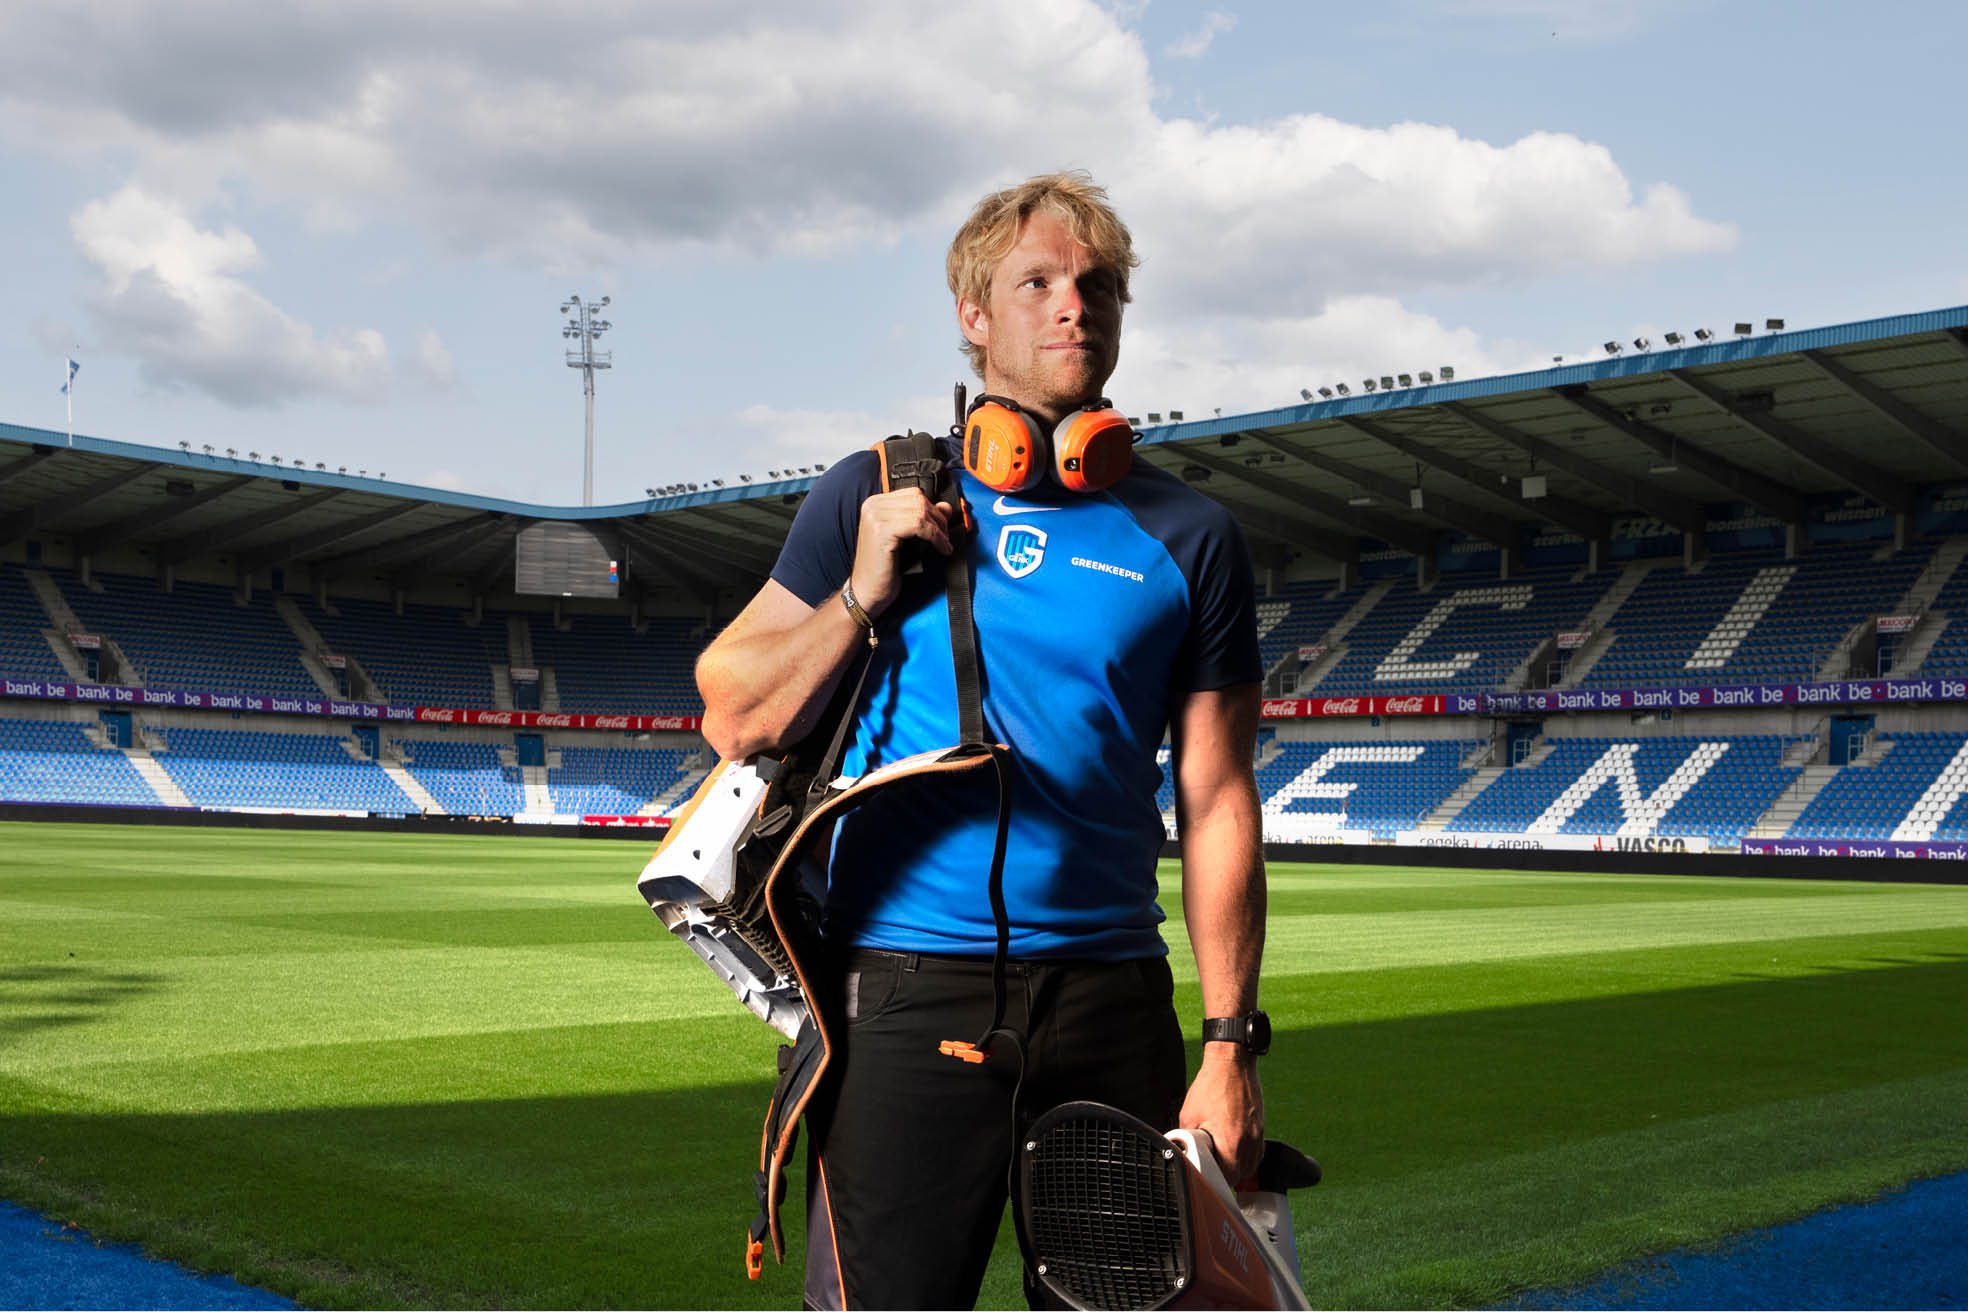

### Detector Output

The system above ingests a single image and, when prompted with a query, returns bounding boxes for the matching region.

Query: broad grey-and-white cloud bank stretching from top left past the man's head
[0,0,1726,283]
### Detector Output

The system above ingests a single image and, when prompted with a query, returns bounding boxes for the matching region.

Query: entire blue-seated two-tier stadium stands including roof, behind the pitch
[0,307,1968,858]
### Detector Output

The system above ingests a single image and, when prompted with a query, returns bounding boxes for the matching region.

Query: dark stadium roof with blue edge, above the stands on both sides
[0,305,1968,602]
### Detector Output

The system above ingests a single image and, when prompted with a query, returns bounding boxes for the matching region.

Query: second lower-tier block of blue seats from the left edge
[155,728,417,814]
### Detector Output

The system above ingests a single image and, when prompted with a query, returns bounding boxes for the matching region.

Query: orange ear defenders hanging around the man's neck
[962,393,1136,492]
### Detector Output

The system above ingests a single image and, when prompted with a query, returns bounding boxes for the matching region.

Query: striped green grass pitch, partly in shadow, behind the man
[0,822,1968,1306]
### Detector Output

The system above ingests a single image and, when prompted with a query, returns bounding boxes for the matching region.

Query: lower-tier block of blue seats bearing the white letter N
[1448,734,1803,846]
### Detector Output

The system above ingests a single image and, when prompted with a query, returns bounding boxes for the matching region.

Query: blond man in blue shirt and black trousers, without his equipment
[697,173,1267,1308]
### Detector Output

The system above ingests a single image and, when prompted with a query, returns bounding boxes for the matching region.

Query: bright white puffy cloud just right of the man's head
[1116,114,1736,315]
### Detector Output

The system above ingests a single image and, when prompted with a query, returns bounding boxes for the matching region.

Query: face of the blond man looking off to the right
[956,210,1122,419]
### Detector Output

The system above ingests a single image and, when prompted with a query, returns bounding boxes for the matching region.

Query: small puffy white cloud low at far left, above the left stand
[69,185,451,405]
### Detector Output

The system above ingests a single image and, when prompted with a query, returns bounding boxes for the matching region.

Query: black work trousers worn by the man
[805,948,1187,1308]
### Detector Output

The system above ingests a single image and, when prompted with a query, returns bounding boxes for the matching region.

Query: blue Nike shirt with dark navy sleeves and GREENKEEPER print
[771,443,1261,960]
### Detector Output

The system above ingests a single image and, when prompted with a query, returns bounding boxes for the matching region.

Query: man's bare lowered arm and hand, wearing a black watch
[1171,683,1265,1184]
